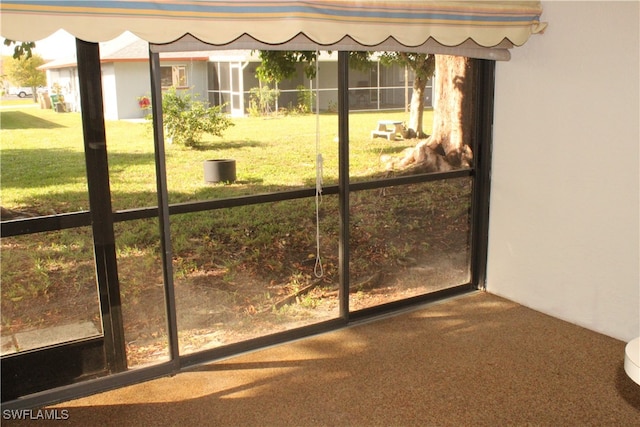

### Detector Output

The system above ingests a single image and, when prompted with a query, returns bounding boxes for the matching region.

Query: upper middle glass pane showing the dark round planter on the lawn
[165,51,338,204]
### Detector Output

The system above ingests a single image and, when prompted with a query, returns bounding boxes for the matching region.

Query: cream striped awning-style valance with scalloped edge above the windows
[0,0,546,59]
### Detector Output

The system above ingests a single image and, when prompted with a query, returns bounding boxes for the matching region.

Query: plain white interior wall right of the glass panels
[487,1,640,341]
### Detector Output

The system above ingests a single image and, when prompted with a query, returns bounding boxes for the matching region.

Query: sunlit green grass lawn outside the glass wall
[0,104,431,297]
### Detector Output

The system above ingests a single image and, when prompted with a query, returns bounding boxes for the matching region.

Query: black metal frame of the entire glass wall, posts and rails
[0,47,495,409]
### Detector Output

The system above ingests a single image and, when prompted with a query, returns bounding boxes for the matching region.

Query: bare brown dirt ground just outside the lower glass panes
[2,181,470,367]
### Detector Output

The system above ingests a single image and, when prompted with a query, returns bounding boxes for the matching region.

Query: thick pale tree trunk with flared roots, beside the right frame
[390,55,476,173]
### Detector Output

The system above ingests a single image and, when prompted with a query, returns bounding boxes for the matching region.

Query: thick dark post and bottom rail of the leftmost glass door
[2,39,127,402]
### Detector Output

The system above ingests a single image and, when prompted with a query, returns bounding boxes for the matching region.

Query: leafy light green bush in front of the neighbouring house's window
[162,87,233,147]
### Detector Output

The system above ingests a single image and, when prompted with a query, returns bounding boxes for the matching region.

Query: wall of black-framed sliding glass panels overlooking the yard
[2,42,493,408]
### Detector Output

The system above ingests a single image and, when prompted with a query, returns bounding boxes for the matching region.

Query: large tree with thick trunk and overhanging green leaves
[257,51,475,173]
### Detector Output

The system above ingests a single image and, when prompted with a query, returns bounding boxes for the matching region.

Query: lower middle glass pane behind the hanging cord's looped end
[171,196,339,354]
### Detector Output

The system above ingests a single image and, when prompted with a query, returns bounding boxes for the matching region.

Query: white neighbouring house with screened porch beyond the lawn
[41,33,432,120]
